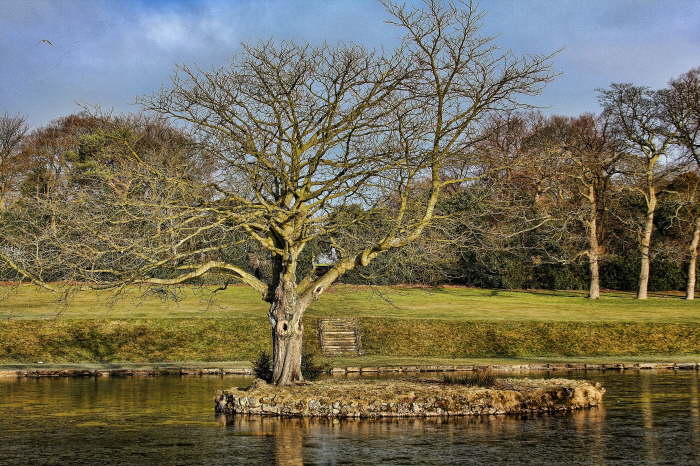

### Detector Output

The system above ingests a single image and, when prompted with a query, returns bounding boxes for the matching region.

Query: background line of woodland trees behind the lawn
[0,64,700,298]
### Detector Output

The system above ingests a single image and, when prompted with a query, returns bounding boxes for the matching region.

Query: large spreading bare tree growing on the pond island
[45,1,552,384]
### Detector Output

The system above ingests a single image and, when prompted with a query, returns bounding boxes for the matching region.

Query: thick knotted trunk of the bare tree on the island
[268,279,306,385]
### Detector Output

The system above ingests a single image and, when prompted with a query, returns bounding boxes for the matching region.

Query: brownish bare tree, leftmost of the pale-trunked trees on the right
[482,113,622,299]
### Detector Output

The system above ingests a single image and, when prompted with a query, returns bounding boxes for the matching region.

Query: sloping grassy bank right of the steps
[360,319,700,358]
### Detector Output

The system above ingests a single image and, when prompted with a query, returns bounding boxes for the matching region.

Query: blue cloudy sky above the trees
[0,0,700,126]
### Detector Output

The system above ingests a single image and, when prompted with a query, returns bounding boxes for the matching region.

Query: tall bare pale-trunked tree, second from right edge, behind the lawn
[599,84,674,299]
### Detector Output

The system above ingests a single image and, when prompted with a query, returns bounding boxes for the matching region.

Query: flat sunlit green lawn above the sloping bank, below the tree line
[0,285,700,323]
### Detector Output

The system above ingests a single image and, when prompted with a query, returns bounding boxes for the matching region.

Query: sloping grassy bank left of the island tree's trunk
[0,318,269,363]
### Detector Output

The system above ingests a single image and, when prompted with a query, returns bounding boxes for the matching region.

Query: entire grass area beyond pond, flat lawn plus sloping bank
[0,286,700,365]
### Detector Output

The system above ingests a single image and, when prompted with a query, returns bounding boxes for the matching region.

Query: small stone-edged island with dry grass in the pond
[214,379,605,418]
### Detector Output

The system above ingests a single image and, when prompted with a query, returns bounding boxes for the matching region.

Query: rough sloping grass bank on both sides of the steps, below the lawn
[0,317,700,365]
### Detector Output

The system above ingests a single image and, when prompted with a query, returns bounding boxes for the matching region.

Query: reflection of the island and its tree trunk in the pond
[217,410,556,465]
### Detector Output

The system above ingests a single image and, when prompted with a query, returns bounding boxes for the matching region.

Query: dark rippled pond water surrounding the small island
[0,371,700,465]
